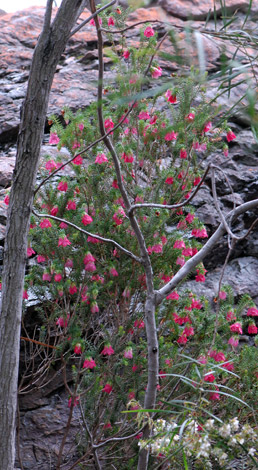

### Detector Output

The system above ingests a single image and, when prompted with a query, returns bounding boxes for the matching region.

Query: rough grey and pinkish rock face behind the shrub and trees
[0,0,258,470]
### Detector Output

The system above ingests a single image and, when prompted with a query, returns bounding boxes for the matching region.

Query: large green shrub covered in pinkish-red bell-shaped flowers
[14,9,258,468]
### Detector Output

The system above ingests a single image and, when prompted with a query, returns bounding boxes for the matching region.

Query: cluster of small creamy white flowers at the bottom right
[139,417,258,469]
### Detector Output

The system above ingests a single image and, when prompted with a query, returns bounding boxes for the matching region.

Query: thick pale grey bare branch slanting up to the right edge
[156,199,258,305]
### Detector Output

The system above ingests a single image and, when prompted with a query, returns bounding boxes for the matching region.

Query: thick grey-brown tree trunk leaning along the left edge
[0,0,85,470]
